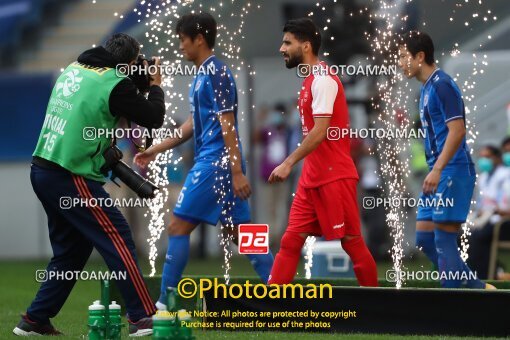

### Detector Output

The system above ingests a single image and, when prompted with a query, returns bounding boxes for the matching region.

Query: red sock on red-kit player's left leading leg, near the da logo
[268,232,305,285]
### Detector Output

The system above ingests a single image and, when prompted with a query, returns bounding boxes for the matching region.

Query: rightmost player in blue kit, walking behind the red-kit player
[399,31,494,289]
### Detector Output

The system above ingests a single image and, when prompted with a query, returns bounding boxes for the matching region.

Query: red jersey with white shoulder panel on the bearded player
[298,62,359,188]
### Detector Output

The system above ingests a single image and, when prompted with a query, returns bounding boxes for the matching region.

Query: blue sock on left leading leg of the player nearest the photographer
[158,235,189,305]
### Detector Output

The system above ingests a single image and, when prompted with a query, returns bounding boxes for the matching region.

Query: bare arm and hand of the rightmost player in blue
[423,119,466,194]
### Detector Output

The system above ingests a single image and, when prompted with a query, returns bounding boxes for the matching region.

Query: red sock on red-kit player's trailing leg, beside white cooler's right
[342,236,379,287]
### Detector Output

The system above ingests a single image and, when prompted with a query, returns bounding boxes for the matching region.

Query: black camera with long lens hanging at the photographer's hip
[101,144,159,198]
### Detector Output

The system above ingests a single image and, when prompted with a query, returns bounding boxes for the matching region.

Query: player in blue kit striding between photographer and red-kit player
[135,13,273,309]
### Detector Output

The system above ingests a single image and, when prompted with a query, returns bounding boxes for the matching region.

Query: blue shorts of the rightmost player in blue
[416,167,476,224]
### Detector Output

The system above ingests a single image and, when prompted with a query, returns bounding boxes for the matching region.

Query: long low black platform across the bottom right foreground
[205,287,510,336]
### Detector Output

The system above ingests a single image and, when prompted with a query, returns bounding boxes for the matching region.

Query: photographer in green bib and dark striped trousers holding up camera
[13,33,165,336]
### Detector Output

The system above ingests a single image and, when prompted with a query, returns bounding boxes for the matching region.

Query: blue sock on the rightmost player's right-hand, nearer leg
[434,229,485,288]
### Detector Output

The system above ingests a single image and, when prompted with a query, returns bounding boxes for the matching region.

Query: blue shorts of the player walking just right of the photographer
[174,163,251,225]
